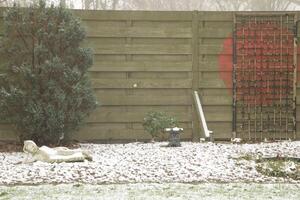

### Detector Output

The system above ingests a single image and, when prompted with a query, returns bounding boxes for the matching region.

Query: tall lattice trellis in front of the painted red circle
[233,14,297,140]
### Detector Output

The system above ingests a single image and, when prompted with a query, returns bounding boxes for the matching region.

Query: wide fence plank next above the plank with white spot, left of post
[89,61,192,72]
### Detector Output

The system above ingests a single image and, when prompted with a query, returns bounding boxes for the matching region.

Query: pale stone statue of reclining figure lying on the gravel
[23,140,92,163]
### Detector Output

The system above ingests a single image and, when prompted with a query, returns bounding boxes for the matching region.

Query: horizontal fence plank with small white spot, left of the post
[92,79,192,88]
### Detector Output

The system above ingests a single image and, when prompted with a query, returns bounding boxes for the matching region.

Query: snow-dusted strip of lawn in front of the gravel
[0,183,300,200]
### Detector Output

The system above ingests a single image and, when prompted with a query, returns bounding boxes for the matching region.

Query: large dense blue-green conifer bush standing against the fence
[0,0,97,144]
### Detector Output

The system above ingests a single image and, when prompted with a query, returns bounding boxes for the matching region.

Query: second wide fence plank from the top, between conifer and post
[86,23,192,38]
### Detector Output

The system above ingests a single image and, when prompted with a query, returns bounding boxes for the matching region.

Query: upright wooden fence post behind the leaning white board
[190,11,200,142]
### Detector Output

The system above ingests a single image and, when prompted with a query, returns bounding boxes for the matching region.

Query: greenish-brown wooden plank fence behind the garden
[0,11,300,141]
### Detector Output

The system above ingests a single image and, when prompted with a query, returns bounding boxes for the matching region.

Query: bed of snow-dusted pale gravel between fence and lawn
[0,141,300,185]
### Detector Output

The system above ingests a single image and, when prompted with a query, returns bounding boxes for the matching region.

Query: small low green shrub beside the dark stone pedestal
[143,111,178,138]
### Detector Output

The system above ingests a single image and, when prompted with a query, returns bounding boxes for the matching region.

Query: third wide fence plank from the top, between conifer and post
[91,44,191,54]
